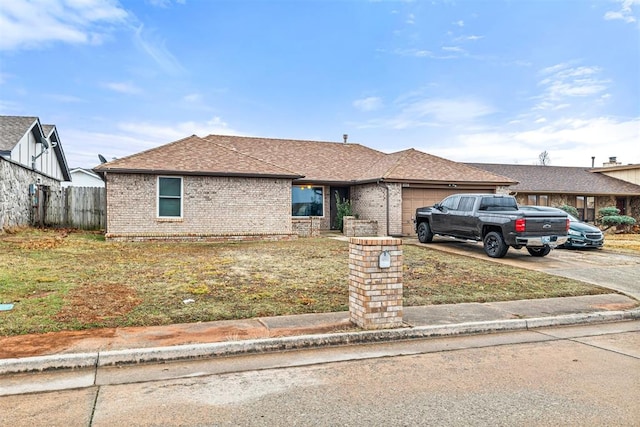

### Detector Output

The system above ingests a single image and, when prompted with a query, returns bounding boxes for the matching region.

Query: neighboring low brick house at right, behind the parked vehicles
[467,163,640,222]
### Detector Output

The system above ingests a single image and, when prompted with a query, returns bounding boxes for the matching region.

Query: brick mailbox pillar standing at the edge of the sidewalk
[349,237,403,329]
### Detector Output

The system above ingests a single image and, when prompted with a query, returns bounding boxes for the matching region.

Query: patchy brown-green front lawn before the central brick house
[0,229,611,336]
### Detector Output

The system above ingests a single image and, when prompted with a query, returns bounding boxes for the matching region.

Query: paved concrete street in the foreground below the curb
[0,321,640,427]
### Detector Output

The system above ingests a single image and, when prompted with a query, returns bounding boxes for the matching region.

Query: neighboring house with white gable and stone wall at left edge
[0,116,71,230]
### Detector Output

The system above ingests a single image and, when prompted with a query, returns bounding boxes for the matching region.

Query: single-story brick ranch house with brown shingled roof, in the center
[94,135,516,240]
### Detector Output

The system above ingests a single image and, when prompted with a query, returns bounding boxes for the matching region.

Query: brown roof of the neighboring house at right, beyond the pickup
[467,163,640,196]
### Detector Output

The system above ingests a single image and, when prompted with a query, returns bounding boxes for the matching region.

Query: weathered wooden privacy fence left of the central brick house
[44,187,107,230]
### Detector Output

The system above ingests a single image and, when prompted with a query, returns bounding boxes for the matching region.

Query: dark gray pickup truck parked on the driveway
[415,194,569,258]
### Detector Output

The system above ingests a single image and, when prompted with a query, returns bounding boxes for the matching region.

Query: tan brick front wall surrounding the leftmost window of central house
[106,174,292,239]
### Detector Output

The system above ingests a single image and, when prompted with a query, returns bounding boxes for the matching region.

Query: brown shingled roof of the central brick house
[96,135,515,185]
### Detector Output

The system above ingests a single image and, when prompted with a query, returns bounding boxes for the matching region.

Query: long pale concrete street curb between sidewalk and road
[0,309,640,375]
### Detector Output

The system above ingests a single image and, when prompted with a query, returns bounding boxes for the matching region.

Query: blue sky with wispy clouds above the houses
[0,0,640,167]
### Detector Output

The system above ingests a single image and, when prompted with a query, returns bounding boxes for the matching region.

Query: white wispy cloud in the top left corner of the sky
[0,0,129,50]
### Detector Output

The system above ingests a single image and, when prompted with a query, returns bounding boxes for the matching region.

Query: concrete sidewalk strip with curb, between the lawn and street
[0,293,640,375]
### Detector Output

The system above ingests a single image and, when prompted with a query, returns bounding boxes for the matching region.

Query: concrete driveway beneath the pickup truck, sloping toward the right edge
[405,237,640,300]
